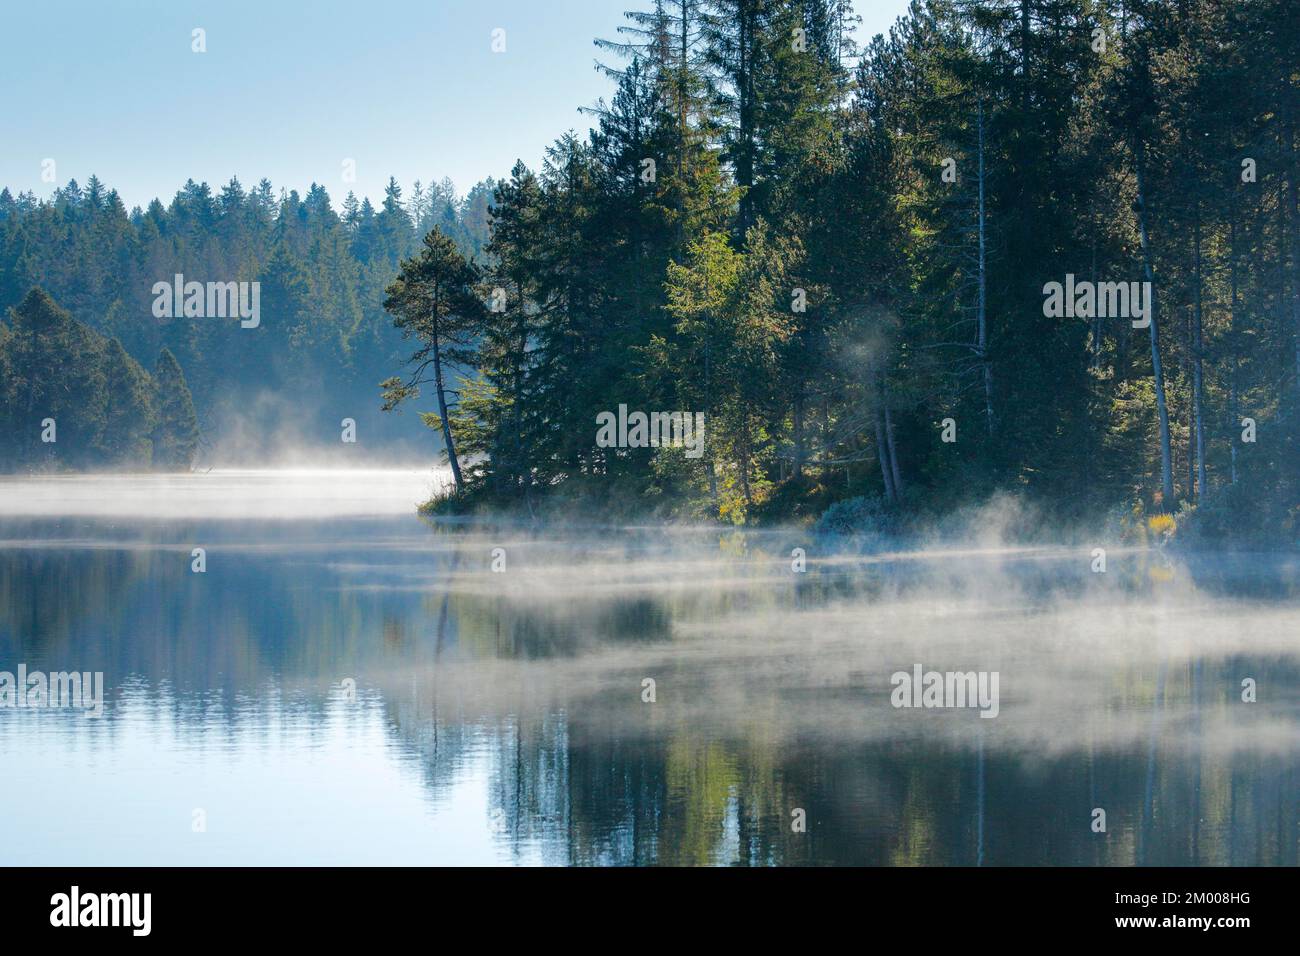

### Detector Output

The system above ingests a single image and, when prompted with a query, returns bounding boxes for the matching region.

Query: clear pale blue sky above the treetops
[0,0,907,207]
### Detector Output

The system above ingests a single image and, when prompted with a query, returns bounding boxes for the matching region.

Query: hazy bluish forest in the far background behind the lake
[0,177,493,460]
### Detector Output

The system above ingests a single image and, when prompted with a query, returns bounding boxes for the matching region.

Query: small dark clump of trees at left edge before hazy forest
[0,289,199,471]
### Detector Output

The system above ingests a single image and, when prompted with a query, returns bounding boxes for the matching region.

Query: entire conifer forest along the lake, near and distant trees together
[0,0,1300,545]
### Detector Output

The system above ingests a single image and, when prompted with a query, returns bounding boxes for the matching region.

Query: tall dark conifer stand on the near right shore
[389,0,1300,540]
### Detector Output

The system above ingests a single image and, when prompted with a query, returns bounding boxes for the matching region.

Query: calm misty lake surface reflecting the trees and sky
[0,472,1300,865]
